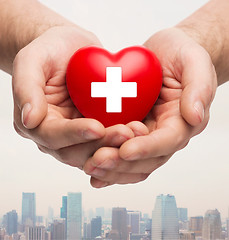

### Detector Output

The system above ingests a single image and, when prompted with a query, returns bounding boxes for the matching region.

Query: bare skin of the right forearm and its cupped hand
[84,0,229,188]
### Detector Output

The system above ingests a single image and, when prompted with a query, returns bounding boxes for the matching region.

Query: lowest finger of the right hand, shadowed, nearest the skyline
[90,172,149,188]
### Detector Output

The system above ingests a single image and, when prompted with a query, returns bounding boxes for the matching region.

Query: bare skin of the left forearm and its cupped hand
[0,0,148,184]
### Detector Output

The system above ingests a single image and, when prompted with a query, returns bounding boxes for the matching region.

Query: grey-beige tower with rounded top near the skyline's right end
[202,209,222,240]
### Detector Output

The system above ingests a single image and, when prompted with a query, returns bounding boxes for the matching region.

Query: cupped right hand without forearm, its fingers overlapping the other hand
[84,28,217,187]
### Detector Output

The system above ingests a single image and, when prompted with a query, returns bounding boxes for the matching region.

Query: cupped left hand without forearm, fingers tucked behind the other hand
[13,27,136,168]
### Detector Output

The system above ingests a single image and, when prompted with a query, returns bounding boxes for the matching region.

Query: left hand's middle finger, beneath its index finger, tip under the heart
[40,125,133,167]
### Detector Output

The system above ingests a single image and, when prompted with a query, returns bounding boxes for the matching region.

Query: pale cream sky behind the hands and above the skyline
[0,0,229,218]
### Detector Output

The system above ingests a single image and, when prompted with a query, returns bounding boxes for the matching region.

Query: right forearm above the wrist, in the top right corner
[177,0,229,85]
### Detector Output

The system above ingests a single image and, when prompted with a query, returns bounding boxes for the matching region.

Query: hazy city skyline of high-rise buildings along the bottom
[0,192,229,240]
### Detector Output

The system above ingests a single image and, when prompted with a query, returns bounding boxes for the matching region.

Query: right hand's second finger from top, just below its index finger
[84,147,172,174]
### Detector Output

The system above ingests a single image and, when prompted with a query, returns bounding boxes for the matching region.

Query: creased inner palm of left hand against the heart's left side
[39,28,100,119]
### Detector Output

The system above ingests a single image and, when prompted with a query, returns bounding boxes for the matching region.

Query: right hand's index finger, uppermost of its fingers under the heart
[120,116,191,161]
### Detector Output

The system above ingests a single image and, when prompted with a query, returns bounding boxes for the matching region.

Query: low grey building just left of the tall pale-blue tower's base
[50,220,66,240]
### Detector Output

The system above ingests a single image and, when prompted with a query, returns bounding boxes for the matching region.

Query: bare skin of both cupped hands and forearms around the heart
[0,0,229,188]
